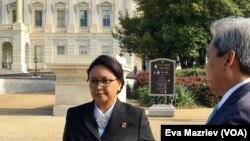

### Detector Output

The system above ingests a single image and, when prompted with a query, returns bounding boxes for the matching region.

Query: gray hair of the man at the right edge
[210,17,250,74]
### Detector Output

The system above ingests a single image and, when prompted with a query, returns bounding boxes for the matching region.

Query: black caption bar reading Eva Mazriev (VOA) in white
[161,125,250,141]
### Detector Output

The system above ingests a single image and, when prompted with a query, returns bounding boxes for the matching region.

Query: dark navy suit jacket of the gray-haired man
[207,83,250,125]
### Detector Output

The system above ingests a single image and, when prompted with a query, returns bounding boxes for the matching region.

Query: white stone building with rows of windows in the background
[0,0,141,74]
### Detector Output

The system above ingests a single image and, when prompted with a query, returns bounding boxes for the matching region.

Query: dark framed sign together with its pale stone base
[148,58,175,117]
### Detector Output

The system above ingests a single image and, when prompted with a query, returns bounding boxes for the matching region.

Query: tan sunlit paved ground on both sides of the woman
[0,92,211,141]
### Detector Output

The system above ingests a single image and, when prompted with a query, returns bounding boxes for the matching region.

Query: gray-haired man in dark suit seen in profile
[206,17,250,125]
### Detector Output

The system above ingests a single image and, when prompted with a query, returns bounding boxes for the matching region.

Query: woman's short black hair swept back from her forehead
[87,55,125,92]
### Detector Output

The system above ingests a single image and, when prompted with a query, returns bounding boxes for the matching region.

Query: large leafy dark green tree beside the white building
[112,0,250,68]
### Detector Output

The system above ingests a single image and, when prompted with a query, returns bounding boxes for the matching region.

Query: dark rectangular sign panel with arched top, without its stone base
[149,58,175,96]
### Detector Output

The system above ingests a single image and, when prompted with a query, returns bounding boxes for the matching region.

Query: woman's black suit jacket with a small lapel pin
[63,100,154,141]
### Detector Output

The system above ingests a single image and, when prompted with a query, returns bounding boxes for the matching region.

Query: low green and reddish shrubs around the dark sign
[130,68,220,107]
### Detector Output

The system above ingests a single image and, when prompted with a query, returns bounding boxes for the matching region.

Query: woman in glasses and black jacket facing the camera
[63,55,154,141]
